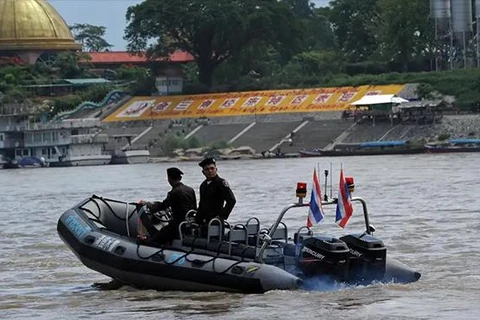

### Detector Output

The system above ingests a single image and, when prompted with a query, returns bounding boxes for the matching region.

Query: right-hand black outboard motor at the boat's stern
[340,233,387,283]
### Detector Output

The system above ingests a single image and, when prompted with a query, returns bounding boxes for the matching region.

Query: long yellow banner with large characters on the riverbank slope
[104,85,404,122]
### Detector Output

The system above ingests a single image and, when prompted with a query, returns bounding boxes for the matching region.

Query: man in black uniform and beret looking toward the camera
[196,158,237,233]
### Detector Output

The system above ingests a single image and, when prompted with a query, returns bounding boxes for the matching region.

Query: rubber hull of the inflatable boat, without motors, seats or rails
[57,196,420,293]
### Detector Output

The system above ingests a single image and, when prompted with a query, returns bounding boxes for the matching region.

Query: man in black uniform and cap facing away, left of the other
[141,167,197,243]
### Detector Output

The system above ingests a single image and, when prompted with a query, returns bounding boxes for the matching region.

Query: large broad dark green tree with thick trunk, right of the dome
[125,0,303,88]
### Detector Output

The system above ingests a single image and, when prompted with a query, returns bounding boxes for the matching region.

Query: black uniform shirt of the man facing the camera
[197,175,237,222]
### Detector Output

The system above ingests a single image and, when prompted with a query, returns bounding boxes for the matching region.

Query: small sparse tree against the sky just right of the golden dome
[70,23,113,52]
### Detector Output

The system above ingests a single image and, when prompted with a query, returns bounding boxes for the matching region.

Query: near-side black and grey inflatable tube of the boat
[57,210,301,293]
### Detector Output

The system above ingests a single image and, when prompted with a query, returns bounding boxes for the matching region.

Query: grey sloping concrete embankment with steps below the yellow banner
[98,112,480,161]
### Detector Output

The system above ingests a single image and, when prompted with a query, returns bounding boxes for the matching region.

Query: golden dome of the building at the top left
[0,0,82,51]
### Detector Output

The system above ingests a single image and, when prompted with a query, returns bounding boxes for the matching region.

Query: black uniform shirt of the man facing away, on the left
[151,182,197,223]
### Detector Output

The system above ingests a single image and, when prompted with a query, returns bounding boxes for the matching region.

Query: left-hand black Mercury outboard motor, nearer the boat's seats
[298,236,350,281]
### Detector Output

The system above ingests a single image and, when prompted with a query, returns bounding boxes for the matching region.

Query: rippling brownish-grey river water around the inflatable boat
[0,153,480,320]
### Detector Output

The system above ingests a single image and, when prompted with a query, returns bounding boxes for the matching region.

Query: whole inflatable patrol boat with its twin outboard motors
[57,190,420,293]
